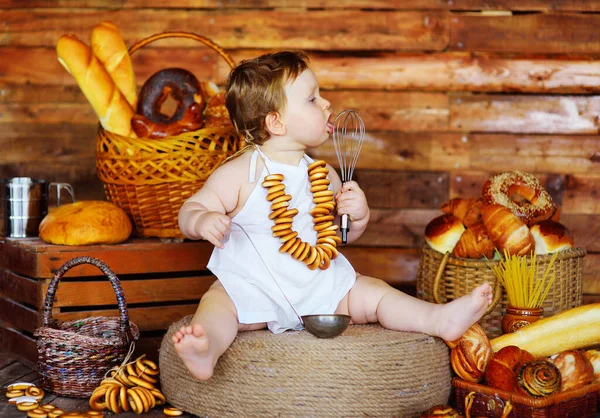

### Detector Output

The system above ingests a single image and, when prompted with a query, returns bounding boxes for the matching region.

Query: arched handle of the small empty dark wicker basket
[44,256,134,344]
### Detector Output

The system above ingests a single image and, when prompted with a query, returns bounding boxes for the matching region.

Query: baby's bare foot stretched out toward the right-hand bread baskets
[438,283,493,341]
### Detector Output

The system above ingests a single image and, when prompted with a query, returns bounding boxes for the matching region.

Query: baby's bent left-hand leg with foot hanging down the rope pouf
[173,281,265,380]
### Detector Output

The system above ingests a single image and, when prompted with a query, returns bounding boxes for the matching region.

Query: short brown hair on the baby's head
[225,51,308,145]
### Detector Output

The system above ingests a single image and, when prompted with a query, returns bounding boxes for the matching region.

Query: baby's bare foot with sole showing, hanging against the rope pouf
[172,324,215,380]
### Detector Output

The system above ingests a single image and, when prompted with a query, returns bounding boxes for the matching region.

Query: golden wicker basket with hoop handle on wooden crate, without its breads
[96,32,242,238]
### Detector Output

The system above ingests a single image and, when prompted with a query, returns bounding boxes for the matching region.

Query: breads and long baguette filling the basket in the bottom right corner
[446,304,600,405]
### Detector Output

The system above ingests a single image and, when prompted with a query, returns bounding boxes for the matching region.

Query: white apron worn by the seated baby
[207,150,356,333]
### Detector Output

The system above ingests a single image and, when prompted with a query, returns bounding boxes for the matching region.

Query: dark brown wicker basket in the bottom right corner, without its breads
[452,377,599,418]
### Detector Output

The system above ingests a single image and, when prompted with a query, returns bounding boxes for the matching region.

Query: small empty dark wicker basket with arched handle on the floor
[34,257,140,398]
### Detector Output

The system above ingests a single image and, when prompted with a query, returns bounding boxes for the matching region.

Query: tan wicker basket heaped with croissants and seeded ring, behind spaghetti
[417,171,586,337]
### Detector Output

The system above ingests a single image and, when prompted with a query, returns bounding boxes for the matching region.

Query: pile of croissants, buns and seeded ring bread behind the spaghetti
[425,171,574,259]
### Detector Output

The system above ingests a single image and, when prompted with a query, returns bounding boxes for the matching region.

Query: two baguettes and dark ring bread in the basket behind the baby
[56,22,231,139]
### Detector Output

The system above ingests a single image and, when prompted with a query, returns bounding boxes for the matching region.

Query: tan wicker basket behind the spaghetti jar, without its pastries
[417,244,586,338]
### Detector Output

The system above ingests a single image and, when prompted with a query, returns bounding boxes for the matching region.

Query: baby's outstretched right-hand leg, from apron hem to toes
[336,274,492,341]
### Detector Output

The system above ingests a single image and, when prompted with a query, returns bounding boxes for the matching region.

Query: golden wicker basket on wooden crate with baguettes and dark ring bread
[57,22,242,238]
